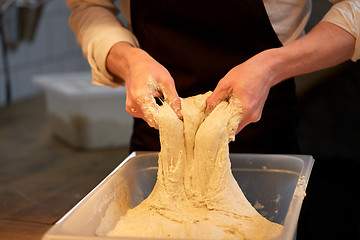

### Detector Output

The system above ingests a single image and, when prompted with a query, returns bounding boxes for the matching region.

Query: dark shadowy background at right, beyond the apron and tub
[297,1,360,240]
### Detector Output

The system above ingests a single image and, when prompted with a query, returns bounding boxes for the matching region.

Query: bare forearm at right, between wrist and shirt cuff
[269,22,355,85]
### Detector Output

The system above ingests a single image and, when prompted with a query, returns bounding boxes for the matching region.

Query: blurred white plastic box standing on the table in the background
[33,72,133,149]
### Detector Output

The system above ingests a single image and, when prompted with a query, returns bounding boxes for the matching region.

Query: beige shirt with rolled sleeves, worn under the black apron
[67,0,360,87]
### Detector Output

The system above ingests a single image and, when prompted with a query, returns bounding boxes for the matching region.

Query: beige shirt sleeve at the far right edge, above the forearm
[322,0,360,62]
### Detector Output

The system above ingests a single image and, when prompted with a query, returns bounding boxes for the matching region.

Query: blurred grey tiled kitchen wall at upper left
[0,0,90,106]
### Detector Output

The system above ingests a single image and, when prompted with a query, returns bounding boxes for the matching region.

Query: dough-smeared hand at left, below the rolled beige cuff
[106,42,182,129]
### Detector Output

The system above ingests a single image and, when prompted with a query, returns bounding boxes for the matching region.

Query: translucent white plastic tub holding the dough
[43,153,314,240]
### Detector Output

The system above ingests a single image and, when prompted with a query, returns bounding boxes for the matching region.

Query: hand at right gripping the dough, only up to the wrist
[206,50,278,134]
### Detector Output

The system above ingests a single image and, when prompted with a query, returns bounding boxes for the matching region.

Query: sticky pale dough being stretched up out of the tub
[100,93,282,239]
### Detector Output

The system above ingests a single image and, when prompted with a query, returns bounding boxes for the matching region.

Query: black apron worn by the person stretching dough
[130,0,299,153]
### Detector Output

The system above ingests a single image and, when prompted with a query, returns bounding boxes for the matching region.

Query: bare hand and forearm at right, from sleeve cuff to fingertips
[207,22,356,133]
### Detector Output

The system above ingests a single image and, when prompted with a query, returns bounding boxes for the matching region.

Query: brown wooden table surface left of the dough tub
[0,96,128,240]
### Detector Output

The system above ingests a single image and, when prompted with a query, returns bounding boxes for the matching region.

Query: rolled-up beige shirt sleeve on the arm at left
[67,0,138,87]
